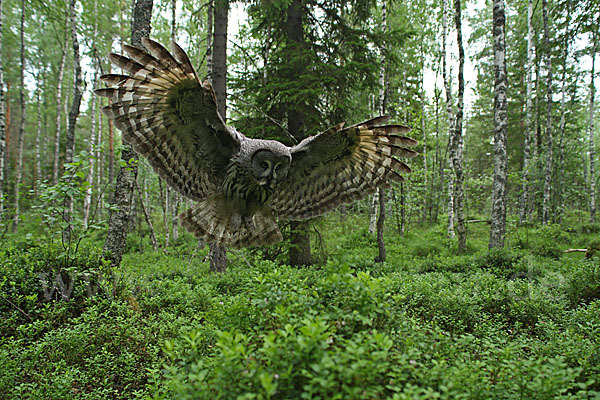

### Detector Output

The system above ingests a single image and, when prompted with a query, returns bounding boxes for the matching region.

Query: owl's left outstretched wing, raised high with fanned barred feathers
[95,38,244,200]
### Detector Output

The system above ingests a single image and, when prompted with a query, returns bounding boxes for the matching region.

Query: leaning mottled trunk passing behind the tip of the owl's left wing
[104,0,152,266]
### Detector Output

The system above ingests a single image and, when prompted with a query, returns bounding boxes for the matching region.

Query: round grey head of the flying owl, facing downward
[250,143,292,188]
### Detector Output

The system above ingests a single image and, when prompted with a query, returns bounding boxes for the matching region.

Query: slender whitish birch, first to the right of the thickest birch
[519,0,535,224]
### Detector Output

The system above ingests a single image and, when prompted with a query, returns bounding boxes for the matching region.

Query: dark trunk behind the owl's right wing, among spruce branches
[286,0,312,266]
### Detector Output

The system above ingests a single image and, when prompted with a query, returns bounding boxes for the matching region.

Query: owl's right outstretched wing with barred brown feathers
[271,117,417,220]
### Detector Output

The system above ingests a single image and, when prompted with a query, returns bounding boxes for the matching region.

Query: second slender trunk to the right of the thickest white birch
[542,0,553,225]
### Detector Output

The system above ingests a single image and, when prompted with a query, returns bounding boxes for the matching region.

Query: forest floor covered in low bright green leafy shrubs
[0,214,600,399]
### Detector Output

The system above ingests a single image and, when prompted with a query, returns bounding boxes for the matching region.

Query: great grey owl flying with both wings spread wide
[95,38,417,248]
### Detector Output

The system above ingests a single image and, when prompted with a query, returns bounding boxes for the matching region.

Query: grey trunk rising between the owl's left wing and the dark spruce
[208,0,229,272]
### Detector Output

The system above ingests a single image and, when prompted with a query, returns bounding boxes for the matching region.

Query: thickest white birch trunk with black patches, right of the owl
[489,0,508,249]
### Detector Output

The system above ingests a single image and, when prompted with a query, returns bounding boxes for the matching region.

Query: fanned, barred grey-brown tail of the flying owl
[179,198,283,249]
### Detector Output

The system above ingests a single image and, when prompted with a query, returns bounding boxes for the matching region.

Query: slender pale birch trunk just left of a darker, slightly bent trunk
[442,0,455,238]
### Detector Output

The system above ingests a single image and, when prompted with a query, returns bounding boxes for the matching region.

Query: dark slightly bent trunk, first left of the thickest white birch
[450,0,467,253]
